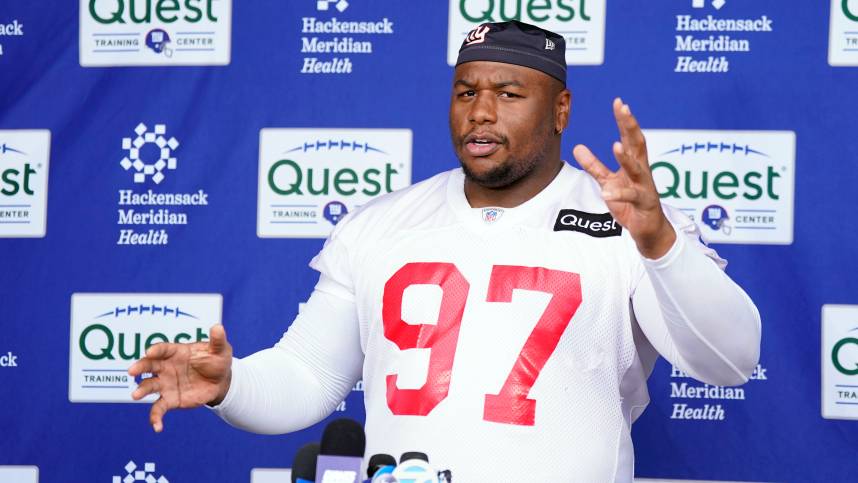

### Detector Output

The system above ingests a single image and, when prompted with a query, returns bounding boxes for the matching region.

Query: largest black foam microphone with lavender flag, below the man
[316,418,366,483]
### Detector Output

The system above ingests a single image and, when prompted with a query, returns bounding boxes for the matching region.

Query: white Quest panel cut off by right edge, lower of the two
[822,305,858,419]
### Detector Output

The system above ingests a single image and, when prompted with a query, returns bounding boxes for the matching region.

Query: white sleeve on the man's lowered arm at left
[212,275,363,434]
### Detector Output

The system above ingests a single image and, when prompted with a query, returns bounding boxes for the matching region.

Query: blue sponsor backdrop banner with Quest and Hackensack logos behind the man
[0,0,858,483]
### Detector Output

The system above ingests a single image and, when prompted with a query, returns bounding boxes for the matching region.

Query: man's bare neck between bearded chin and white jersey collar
[465,158,564,208]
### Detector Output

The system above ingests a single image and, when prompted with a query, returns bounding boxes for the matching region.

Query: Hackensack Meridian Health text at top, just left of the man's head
[299,0,394,74]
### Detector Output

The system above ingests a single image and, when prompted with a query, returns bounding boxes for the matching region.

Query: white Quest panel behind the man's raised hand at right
[644,129,795,245]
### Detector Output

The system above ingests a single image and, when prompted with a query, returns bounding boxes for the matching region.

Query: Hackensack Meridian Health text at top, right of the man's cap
[672,0,774,74]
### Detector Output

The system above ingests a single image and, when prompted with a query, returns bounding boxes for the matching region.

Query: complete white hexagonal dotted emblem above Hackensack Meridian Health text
[119,122,179,184]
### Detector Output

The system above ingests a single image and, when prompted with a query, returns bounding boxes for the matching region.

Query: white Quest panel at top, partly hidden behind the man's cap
[447,0,605,65]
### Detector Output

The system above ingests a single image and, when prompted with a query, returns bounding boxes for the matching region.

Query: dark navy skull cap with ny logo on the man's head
[456,20,566,85]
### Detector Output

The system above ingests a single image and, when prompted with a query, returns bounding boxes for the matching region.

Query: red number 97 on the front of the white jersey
[382,263,581,426]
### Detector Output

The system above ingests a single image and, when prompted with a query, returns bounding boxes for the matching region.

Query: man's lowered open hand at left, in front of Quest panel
[128,324,232,433]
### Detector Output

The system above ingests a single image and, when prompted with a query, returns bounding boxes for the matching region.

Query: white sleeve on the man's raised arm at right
[632,208,761,385]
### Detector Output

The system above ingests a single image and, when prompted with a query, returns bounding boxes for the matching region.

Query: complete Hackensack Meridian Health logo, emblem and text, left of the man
[116,122,209,245]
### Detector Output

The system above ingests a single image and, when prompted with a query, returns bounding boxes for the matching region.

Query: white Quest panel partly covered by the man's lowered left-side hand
[69,293,223,403]
